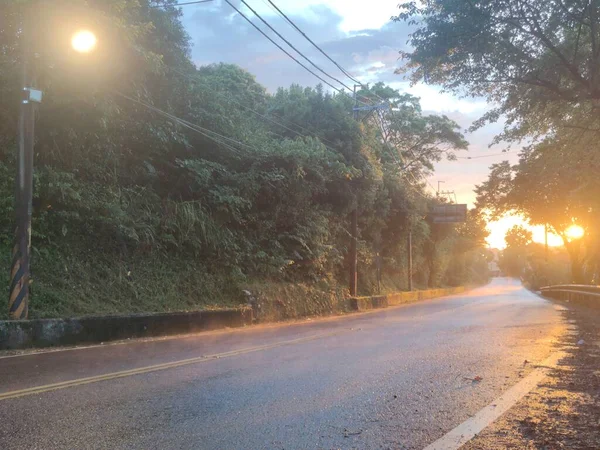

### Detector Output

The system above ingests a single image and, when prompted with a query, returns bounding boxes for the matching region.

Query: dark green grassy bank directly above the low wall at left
[0,243,245,319]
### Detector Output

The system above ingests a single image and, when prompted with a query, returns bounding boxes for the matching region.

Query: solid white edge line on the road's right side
[424,352,565,450]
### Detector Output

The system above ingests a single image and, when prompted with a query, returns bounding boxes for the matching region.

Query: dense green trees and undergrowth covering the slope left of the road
[0,0,487,317]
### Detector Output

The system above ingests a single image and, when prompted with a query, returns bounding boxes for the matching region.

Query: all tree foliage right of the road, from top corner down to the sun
[395,0,600,283]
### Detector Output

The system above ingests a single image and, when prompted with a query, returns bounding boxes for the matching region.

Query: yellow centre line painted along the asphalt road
[0,328,346,401]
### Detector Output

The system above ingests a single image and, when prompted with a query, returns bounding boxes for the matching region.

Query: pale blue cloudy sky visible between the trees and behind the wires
[180,0,560,248]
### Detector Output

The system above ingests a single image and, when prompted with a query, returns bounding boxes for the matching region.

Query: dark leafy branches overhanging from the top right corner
[394,0,600,140]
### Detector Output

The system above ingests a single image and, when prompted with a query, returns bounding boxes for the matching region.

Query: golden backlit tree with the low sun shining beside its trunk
[475,146,598,283]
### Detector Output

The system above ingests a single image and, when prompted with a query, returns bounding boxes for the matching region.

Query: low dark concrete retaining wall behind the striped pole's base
[0,308,252,350]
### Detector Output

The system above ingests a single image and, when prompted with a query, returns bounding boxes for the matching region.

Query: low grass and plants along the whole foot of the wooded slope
[0,241,478,321]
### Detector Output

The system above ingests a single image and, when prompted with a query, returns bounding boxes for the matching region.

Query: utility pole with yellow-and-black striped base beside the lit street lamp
[8,10,42,319]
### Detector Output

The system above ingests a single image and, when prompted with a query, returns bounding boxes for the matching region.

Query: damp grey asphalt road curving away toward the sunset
[0,278,566,450]
